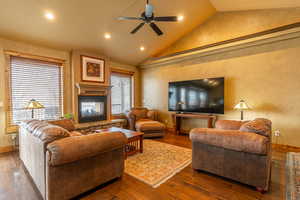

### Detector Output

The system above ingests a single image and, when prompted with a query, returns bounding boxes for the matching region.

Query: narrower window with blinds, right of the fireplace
[111,72,133,115]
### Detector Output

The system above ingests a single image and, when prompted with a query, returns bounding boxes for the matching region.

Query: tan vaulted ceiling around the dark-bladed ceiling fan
[0,0,300,65]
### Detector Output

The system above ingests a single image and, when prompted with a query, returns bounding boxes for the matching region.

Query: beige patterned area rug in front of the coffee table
[125,140,192,188]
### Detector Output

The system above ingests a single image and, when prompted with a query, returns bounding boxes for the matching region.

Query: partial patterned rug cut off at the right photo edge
[286,152,300,200]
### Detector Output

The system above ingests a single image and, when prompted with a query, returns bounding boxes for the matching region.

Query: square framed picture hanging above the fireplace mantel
[81,55,105,83]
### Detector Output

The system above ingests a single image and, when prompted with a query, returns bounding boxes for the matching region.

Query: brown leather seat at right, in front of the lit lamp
[190,118,272,192]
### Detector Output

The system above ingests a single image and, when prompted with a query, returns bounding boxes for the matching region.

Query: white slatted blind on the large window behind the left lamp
[10,57,63,125]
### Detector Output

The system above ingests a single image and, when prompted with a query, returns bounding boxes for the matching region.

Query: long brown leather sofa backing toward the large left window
[19,120,127,200]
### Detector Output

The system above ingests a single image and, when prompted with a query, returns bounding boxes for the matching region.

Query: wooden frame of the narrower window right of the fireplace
[109,68,135,119]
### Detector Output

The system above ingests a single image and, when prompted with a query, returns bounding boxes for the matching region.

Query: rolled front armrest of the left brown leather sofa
[47,132,127,166]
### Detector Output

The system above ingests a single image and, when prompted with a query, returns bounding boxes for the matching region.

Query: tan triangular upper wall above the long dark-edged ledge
[159,8,300,56]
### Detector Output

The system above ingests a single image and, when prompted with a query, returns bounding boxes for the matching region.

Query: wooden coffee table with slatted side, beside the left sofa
[96,127,144,157]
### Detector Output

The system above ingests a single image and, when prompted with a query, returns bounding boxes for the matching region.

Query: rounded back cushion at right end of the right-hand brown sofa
[240,118,272,136]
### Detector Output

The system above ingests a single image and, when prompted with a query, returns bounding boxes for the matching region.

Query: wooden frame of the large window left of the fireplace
[4,50,66,134]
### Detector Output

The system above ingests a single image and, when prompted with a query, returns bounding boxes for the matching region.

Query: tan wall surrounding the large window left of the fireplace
[0,38,72,147]
